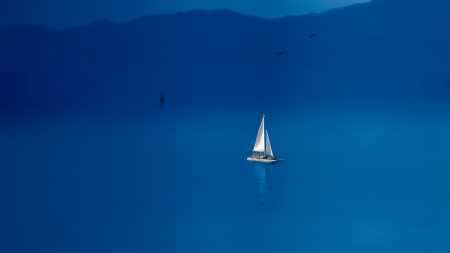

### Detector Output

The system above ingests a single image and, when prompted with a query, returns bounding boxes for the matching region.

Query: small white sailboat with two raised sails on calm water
[247,115,278,163]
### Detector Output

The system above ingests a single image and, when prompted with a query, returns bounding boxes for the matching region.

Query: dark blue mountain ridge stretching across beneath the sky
[0,0,450,72]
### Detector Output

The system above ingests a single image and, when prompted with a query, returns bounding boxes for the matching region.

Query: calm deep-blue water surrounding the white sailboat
[0,73,450,252]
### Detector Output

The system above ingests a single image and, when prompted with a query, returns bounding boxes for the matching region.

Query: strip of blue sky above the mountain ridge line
[0,0,369,29]
